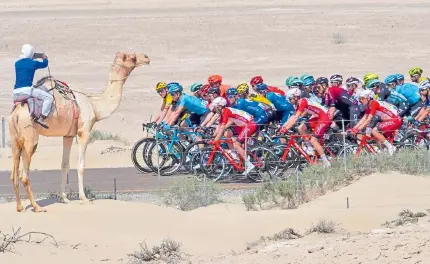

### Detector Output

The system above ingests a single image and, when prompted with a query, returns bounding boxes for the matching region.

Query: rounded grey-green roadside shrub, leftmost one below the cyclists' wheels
[162,178,220,211]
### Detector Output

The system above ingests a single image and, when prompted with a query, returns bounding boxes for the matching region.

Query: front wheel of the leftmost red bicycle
[200,146,228,182]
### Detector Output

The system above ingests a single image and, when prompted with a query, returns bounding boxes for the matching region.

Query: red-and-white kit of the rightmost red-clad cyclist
[366,100,403,136]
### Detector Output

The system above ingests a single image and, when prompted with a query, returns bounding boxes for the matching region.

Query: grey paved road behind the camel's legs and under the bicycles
[0,167,259,196]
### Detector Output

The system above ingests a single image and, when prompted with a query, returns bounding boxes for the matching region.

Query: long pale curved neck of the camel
[91,65,130,121]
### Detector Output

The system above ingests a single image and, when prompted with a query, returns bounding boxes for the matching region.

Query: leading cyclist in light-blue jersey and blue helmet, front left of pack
[165,82,209,128]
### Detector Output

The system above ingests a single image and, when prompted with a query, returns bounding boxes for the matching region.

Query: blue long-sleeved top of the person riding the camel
[14,58,48,89]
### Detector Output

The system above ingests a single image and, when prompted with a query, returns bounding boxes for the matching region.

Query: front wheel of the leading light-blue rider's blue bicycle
[148,141,185,176]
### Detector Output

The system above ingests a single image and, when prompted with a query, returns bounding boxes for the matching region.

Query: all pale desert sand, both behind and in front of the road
[0,0,430,264]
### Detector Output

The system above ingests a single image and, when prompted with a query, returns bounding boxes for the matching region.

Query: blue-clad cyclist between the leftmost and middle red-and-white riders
[256,83,294,125]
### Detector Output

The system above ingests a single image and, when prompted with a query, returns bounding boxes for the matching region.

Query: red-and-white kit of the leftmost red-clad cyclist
[220,107,257,142]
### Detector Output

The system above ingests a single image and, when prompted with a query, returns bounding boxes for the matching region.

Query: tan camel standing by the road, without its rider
[9,52,150,212]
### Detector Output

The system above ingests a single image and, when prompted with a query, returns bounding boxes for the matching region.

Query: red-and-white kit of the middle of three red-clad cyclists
[297,98,331,137]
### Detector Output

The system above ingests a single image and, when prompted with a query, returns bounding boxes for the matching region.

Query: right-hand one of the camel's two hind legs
[20,138,46,212]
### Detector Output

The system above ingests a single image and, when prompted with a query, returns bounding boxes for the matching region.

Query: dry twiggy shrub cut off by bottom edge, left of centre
[128,239,182,264]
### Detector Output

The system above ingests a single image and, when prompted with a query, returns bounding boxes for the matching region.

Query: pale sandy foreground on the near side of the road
[0,173,430,263]
